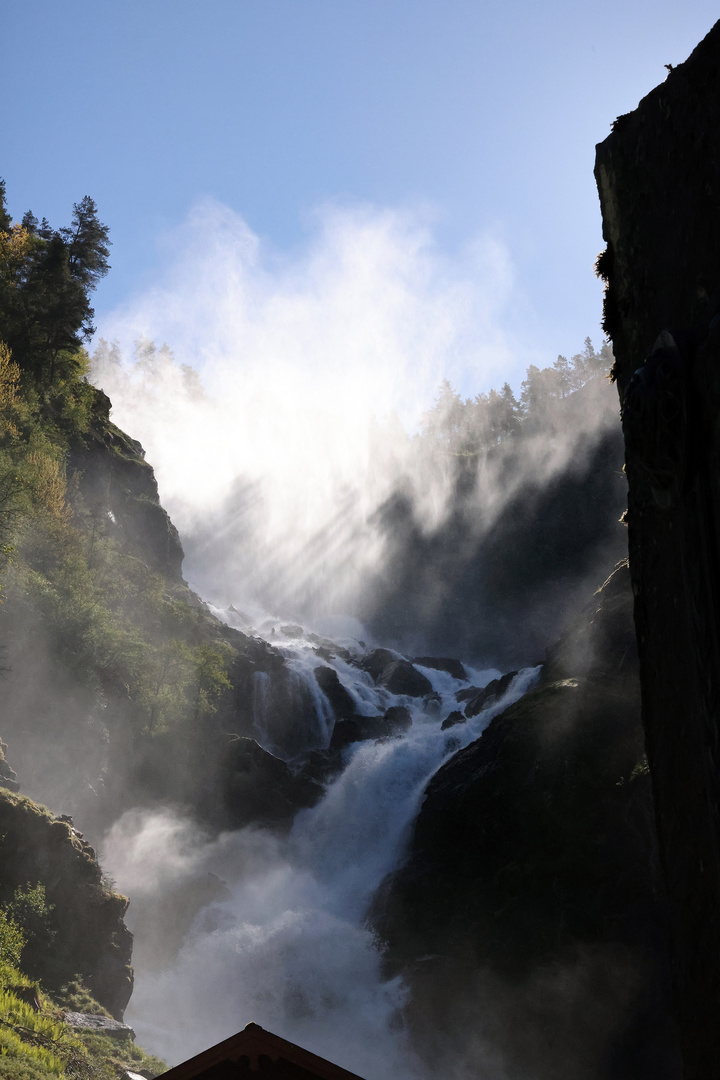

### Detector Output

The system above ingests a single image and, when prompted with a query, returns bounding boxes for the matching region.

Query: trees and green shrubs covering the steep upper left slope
[0,177,232,756]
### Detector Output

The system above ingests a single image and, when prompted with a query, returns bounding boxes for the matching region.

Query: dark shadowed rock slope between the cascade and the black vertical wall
[376,565,680,1080]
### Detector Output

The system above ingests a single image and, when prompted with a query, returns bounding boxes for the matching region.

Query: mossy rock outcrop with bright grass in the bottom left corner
[0,792,165,1080]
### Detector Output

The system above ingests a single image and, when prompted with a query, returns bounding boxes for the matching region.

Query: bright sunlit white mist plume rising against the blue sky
[94,202,616,618]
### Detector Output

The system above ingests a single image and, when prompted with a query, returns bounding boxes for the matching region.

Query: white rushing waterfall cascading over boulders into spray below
[105,611,538,1080]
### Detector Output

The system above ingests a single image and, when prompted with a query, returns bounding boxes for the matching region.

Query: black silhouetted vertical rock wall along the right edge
[595,24,720,1080]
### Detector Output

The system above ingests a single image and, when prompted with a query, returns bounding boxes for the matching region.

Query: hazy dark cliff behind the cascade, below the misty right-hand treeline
[361,380,627,669]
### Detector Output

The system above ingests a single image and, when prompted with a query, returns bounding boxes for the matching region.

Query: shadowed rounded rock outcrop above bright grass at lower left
[0,789,133,1020]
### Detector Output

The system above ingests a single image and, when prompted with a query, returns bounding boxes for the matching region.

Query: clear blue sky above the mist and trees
[0,0,718,389]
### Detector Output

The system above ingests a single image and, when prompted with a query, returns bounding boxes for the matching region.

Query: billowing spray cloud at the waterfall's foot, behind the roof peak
[104,810,425,1080]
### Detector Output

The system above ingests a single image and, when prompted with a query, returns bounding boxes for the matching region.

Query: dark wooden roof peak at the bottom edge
[159,1024,363,1080]
